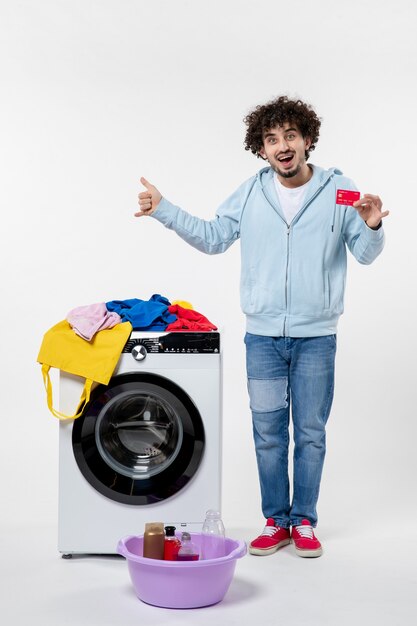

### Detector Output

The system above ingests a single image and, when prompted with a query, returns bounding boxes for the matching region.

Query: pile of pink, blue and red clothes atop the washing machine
[66,294,217,341]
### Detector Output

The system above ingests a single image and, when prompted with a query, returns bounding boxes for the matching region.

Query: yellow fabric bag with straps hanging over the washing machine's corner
[37,320,132,420]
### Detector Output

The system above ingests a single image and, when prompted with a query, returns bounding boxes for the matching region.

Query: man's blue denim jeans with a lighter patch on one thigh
[245,333,336,528]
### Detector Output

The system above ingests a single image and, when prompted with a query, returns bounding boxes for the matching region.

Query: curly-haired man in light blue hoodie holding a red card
[135,96,388,557]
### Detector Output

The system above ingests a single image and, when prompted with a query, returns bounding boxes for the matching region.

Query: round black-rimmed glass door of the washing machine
[72,374,204,505]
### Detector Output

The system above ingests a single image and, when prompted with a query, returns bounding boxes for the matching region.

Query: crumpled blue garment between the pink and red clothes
[106,294,177,331]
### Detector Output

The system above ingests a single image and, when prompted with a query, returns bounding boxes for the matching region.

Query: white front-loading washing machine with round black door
[58,332,222,556]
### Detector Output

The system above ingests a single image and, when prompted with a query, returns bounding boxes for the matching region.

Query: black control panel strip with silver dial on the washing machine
[123,332,220,360]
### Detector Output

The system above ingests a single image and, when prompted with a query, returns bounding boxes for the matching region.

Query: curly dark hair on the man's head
[243,96,321,160]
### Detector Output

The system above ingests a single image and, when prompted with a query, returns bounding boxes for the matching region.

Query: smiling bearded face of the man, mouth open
[259,122,311,187]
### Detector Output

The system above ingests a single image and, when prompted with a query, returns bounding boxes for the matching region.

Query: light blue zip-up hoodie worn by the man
[152,165,384,337]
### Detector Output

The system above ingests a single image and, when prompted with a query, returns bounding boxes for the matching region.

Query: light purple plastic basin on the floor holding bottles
[117,533,246,609]
